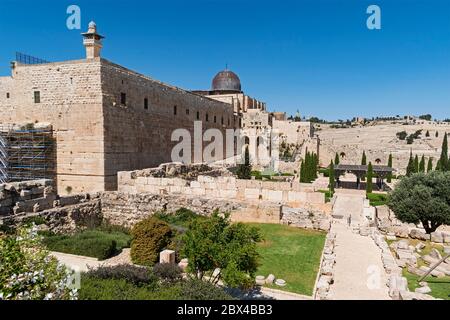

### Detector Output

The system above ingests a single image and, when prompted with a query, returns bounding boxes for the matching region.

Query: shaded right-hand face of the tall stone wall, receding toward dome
[101,60,238,190]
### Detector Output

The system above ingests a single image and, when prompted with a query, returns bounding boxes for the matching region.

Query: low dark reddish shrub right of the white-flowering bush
[86,264,157,287]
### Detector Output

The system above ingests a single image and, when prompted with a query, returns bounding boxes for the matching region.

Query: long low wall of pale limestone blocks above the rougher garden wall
[118,171,325,205]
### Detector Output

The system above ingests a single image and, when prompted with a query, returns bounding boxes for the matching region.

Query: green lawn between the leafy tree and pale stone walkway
[251,223,326,295]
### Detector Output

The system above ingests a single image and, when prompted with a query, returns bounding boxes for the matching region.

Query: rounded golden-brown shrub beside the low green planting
[131,217,173,266]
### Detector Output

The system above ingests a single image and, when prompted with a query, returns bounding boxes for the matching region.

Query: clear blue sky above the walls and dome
[0,0,450,119]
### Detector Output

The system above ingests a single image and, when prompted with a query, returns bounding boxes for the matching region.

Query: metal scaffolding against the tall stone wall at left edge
[0,125,56,183]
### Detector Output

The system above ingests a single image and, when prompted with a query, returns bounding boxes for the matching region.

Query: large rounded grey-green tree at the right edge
[388,171,450,233]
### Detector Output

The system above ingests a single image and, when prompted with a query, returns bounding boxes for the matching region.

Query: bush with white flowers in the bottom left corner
[0,225,77,300]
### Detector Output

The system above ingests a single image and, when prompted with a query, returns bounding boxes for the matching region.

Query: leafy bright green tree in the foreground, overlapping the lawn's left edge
[184,211,261,288]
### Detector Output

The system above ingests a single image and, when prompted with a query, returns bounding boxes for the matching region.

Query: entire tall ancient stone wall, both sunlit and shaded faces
[0,58,238,194]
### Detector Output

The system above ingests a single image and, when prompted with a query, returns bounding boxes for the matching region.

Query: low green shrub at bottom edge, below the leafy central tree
[181,279,233,300]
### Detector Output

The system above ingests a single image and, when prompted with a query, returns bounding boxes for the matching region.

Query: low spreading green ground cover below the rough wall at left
[43,230,131,260]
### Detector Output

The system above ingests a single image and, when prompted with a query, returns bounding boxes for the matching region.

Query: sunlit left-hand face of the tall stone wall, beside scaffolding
[0,59,104,193]
